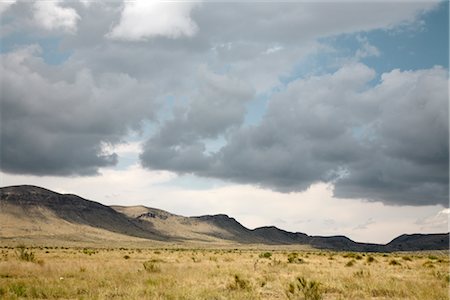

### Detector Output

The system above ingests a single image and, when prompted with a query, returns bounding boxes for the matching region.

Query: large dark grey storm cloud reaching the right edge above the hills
[141,64,449,205]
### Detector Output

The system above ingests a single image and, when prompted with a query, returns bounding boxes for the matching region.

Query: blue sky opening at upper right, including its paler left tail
[279,1,449,85]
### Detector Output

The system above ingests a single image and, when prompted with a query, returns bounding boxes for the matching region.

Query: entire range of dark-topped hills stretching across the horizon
[0,185,449,252]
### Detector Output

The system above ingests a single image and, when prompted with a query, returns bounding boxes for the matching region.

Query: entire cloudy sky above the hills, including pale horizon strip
[0,0,450,243]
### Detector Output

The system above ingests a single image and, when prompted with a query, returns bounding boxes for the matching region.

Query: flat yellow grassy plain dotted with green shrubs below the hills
[0,246,450,300]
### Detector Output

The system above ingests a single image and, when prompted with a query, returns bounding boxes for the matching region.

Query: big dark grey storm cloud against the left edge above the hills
[0,46,160,175]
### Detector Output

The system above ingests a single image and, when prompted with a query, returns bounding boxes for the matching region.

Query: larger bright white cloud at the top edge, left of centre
[107,0,198,41]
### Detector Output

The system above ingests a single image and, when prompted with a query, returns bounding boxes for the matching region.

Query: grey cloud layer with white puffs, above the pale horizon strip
[0,1,449,206]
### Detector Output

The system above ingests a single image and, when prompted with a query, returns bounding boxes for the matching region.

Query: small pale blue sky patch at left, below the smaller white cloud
[0,33,73,65]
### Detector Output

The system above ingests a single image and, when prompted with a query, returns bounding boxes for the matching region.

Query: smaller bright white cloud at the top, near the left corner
[34,1,80,32]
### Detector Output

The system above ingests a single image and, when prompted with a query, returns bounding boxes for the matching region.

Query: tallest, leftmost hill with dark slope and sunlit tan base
[0,186,166,240]
